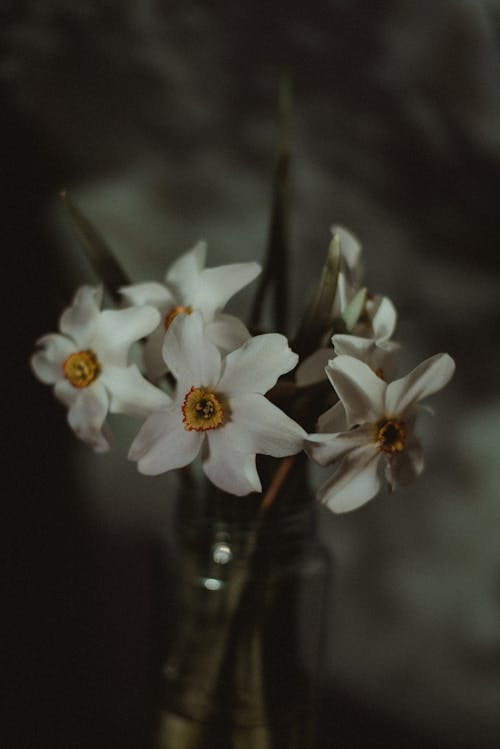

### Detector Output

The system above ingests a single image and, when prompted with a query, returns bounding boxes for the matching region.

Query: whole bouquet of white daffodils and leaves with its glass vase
[31,175,454,749]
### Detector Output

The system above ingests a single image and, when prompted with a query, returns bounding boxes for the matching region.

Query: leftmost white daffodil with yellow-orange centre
[31,286,170,452]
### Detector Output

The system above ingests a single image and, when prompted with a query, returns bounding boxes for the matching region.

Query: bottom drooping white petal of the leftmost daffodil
[68,381,109,452]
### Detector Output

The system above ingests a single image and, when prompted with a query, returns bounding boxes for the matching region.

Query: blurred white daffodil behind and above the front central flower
[120,242,261,380]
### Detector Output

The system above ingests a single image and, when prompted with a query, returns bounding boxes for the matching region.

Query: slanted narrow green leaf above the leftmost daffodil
[59,190,130,301]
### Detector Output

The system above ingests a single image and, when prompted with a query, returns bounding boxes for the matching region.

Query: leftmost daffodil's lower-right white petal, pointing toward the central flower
[100,364,172,416]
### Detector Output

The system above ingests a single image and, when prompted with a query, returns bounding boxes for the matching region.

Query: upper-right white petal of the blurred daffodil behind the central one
[192,263,261,322]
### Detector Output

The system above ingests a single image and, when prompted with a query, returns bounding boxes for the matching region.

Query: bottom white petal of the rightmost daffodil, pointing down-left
[318,445,380,513]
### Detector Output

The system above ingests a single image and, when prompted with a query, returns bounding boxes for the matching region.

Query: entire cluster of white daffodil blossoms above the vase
[31,227,454,512]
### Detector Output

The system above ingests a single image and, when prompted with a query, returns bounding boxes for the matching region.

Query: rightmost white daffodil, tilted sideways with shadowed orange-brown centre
[305,354,455,513]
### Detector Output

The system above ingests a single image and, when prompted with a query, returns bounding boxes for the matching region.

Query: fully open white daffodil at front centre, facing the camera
[129,312,306,496]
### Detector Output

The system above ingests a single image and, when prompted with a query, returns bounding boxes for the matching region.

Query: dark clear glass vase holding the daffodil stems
[156,462,330,749]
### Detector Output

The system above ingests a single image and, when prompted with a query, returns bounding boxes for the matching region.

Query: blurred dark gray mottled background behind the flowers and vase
[0,0,500,749]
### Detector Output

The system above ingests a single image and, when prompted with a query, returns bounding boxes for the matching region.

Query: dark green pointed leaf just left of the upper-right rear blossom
[292,234,341,359]
